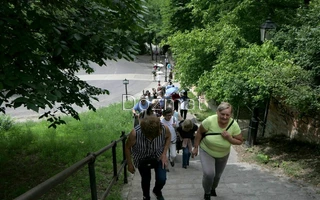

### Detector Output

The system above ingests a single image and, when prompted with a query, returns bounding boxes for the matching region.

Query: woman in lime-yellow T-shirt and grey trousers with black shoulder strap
[192,102,243,200]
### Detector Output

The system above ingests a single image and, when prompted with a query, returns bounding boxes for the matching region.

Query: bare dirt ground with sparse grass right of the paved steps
[233,136,320,192]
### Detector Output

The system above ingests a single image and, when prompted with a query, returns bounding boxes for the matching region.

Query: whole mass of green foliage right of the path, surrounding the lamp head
[149,0,320,114]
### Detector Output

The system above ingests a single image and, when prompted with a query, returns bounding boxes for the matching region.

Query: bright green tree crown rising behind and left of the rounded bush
[168,16,248,87]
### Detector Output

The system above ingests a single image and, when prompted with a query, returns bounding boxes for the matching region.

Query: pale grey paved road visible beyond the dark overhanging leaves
[6,56,159,121]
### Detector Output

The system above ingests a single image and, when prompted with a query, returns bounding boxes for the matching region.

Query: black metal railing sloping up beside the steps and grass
[15,132,128,200]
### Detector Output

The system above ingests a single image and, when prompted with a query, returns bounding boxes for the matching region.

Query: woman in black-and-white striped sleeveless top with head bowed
[125,115,171,200]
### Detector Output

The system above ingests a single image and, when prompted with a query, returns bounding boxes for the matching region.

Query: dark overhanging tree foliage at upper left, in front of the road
[0,0,143,127]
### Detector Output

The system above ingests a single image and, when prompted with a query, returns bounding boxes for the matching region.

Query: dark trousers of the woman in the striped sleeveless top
[138,160,167,198]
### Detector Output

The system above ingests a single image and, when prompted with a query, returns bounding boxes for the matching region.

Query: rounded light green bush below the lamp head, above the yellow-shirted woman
[197,42,315,111]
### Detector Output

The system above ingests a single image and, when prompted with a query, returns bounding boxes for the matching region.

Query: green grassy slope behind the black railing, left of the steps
[0,104,132,200]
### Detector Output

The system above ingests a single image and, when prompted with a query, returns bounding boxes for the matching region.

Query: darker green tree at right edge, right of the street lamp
[273,0,320,87]
